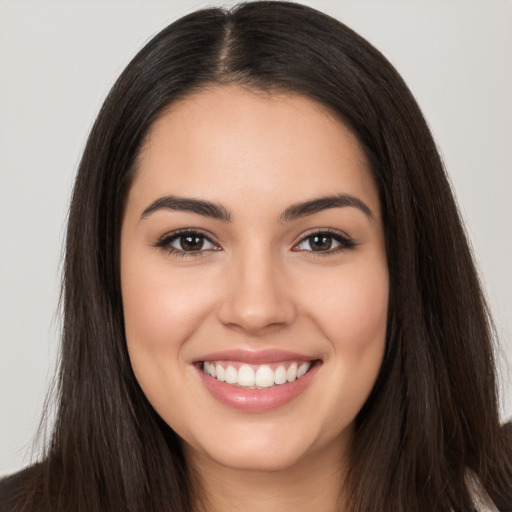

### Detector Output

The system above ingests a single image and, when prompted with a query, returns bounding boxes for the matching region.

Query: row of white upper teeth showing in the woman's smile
[203,361,311,388]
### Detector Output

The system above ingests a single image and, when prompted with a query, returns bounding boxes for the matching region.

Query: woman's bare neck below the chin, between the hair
[185,436,345,512]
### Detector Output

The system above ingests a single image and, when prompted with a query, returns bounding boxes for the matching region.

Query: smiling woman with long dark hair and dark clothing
[2,2,512,512]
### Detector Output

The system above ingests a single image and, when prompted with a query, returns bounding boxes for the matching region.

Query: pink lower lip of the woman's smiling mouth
[198,362,321,412]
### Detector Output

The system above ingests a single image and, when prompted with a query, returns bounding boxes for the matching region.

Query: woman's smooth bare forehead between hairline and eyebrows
[126,86,378,216]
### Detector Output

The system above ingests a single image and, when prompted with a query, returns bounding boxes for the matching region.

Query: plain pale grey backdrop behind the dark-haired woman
[0,0,512,475]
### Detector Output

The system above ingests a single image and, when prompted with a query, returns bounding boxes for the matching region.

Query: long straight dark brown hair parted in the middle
[5,2,512,512]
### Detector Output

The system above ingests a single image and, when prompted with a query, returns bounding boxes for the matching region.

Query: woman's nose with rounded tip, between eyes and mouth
[219,251,296,335]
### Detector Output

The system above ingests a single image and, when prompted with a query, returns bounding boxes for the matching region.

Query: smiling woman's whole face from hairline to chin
[121,86,388,470]
